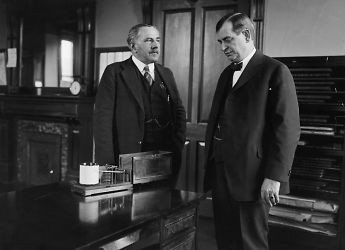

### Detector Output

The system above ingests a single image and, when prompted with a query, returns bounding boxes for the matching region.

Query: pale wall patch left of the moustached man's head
[95,0,143,48]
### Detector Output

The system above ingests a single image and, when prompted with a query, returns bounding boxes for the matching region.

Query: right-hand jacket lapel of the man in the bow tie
[232,51,262,92]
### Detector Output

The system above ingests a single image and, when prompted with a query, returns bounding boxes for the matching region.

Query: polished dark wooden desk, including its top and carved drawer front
[0,184,203,250]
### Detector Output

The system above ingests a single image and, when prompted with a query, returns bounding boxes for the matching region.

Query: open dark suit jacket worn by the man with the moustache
[93,58,186,168]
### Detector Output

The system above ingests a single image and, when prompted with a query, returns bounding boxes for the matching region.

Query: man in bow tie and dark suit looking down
[204,13,300,250]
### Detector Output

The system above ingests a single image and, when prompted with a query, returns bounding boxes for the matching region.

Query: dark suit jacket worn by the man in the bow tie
[204,51,300,201]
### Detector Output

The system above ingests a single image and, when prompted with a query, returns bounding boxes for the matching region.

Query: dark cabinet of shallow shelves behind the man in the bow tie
[270,56,345,250]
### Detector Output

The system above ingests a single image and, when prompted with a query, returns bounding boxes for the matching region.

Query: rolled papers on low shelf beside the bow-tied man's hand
[269,195,339,236]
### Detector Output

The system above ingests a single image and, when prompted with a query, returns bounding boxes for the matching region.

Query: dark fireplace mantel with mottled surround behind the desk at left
[0,96,93,186]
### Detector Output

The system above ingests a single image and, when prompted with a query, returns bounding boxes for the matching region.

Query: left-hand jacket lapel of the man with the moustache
[121,58,144,110]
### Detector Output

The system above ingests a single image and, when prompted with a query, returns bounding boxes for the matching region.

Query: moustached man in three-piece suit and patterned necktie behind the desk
[94,24,186,182]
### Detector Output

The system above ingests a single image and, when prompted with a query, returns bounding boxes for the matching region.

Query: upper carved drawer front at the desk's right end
[162,208,196,240]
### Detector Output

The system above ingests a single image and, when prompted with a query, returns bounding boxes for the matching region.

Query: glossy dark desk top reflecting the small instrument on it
[0,184,204,250]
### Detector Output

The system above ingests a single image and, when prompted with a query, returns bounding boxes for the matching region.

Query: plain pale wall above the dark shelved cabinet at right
[264,0,345,56]
